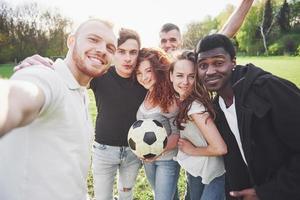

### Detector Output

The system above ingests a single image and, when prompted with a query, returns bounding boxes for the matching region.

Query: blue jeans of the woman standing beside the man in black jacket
[187,173,225,200]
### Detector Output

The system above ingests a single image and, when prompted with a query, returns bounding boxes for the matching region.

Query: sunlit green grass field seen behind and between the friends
[0,56,300,200]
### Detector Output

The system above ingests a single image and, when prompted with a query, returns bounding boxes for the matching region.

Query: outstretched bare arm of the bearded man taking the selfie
[0,80,45,137]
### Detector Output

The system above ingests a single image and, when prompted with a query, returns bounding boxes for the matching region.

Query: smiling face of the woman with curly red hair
[136,60,156,91]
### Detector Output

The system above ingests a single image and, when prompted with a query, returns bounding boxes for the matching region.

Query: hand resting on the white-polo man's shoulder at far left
[14,54,53,71]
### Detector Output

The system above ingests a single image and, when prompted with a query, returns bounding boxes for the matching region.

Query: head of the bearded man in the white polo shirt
[68,20,116,77]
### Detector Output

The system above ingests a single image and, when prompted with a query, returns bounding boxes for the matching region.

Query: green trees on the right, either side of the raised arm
[183,0,300,56]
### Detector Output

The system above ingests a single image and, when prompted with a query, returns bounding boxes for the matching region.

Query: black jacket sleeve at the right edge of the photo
[256,76,300,200]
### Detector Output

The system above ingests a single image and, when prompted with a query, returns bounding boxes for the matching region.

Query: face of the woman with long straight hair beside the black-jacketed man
[170,59,195,100]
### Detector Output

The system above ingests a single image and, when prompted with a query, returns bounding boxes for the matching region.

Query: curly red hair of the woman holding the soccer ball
[135,48,175,112]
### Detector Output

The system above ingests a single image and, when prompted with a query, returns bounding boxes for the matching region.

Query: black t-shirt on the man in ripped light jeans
[90,66,146,146]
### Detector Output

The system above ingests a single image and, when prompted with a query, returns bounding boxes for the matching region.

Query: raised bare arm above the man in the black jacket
[218,0,254,38]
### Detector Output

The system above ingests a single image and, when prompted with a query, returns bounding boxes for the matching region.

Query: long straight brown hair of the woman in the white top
[170,51,216,130]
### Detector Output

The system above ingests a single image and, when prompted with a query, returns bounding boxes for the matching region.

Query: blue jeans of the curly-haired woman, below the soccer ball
[144,160,180,200]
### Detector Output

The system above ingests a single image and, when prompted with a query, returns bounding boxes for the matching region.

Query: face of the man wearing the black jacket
[197,47,236,93]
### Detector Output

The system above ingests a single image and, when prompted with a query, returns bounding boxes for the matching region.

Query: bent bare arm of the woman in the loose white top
[178,112,227,156]
